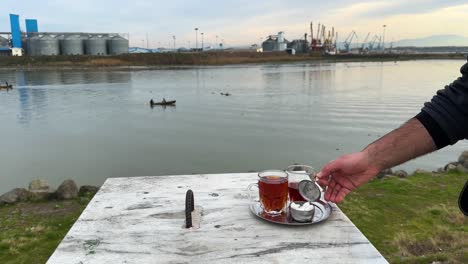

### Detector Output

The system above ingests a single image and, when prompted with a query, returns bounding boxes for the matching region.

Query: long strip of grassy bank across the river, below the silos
[0,51,464,68]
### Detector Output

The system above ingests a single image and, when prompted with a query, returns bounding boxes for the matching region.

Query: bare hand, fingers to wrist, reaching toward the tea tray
[317,151,380,203]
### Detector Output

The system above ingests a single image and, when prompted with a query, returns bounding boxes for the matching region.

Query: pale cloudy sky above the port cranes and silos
[0,0,468,48]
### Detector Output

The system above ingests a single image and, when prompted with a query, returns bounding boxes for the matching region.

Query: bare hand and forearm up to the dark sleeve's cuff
[317,118,437,203]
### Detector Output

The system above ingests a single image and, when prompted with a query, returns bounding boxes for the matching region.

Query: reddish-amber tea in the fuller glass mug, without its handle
[258,176,288,213]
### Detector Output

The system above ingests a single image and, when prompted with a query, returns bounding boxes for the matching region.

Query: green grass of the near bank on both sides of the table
[0,172,468,264]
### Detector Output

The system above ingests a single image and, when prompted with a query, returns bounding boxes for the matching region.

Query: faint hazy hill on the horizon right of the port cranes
[394,35,468,47]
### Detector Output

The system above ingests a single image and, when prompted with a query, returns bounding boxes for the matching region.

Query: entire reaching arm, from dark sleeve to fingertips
[317,60,468,203]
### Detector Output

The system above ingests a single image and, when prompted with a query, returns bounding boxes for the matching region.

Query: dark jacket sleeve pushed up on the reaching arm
[416,59,468,149]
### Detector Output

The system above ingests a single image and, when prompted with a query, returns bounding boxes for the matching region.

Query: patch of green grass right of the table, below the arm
[340,172,468,263]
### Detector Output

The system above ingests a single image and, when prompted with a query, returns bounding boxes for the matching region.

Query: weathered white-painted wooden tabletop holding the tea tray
[48,173,387,264]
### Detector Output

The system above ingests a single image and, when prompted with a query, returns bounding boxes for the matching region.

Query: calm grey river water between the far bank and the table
[0,60,468,193]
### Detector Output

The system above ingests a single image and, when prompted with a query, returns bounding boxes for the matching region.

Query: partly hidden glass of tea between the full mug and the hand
[286,165,316,202]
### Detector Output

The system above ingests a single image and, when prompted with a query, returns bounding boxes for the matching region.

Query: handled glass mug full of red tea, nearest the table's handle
[248,170,288,215]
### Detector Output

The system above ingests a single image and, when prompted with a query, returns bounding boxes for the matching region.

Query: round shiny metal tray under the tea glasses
[249,200,332,226]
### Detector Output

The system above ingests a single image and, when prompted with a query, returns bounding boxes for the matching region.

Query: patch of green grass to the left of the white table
[0,197,90,264]
